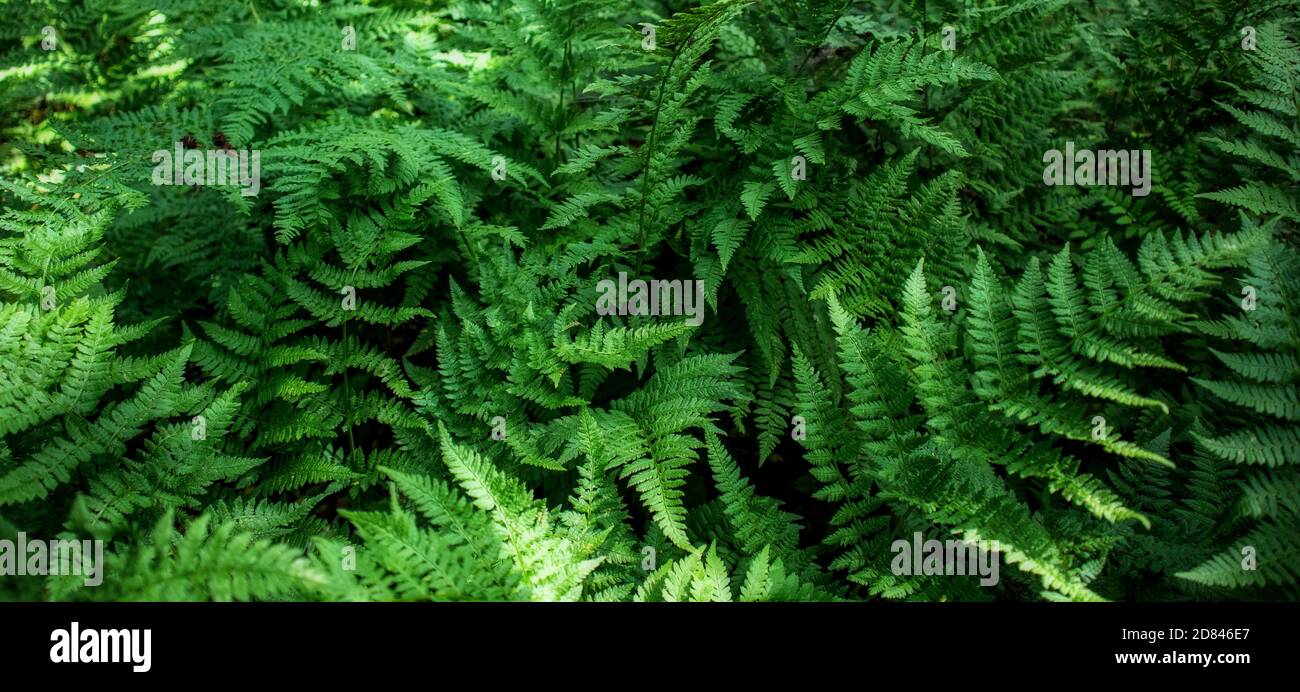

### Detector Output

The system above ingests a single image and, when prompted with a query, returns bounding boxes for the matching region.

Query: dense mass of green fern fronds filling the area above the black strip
[0,0,1300,601]
